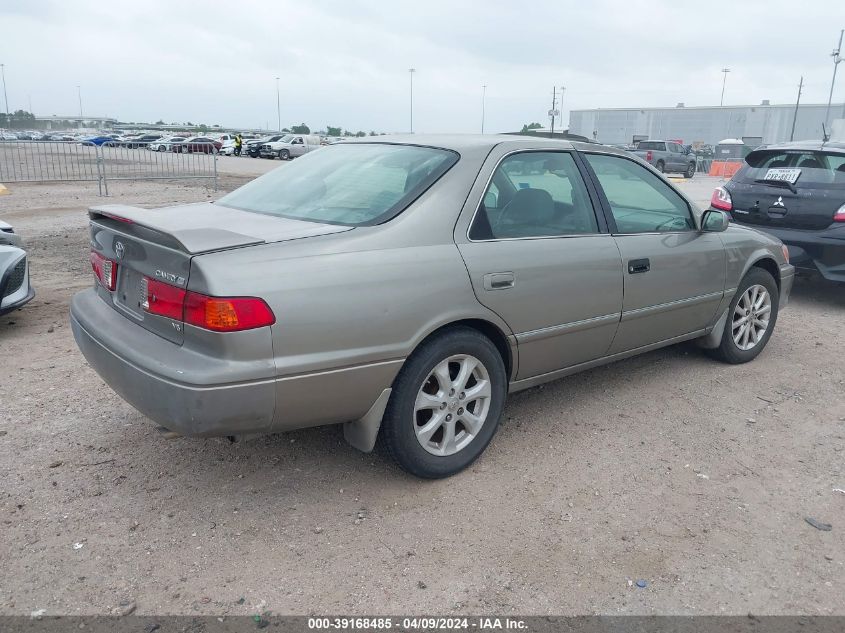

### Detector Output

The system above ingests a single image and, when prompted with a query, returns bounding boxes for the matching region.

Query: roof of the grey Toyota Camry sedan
[343,134,628,156]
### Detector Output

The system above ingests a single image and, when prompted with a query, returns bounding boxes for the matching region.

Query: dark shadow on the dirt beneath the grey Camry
[113,334,720,505]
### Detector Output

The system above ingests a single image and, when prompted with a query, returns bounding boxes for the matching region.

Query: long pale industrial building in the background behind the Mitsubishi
[569,101,845,145]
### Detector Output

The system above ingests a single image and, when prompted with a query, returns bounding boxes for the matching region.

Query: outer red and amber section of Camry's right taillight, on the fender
[185,292,276,332]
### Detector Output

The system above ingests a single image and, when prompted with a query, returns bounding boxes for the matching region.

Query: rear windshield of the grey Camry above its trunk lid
[217,143,458,226]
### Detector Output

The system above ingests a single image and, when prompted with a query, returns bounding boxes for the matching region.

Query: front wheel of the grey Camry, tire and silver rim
[711,267,780,364]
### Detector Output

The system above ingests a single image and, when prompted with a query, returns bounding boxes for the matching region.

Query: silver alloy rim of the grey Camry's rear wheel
[414,354,492,457]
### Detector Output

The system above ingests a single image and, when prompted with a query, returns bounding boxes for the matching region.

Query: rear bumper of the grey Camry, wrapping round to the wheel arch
[70,289,404,436]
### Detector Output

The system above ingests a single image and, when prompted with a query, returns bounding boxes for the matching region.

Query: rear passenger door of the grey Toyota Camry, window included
[455,151,622,379]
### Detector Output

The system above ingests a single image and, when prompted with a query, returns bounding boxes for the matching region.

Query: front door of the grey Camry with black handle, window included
[584,154,726,353]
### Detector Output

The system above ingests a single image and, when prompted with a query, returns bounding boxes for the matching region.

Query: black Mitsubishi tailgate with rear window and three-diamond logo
[728,149,845,230]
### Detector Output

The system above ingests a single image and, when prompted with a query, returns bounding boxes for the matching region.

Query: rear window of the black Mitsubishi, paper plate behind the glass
[735,150,845,189]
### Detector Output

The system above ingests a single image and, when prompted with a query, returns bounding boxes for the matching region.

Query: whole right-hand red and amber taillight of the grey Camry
[143,277,276,332]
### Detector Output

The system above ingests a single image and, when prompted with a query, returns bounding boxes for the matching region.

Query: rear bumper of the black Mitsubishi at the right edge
[734,218,845,282]
